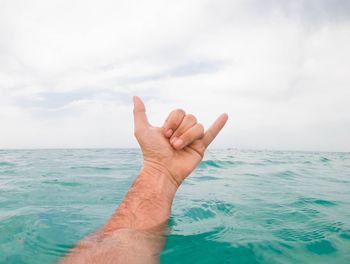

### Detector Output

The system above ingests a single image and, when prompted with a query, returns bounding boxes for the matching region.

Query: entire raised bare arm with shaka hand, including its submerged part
[60,96,228,264]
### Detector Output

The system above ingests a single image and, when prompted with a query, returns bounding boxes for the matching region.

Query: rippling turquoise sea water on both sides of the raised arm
[0,149,350,264]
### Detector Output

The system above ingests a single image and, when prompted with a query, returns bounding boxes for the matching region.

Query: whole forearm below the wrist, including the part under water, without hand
[61,162,177,264]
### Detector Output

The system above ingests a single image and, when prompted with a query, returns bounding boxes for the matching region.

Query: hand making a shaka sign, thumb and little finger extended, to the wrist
[133,96,228,186]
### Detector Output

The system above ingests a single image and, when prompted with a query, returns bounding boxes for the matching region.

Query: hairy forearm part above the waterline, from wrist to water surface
[102,162,177,233]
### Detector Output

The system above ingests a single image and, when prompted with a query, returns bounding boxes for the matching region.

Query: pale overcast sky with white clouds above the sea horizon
[0,0,350,151]
